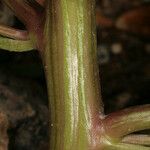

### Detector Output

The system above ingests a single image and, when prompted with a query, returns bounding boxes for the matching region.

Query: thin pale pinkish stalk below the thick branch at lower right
[122,134,150,146]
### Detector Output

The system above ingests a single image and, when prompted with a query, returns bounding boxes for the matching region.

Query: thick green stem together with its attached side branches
[0,0,150,150]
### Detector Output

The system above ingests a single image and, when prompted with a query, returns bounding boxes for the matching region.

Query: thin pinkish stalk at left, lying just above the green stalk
[0,25,29,40]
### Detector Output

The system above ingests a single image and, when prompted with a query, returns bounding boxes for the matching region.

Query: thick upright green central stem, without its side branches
[42,0,103,150]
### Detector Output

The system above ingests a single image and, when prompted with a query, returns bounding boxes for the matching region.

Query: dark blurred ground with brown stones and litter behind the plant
[0,0,150,150]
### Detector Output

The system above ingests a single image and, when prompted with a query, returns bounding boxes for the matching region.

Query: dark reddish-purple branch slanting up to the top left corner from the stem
[2,0,45,53]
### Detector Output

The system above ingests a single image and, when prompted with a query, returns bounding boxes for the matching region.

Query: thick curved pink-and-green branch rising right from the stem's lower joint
[103,105,150,141]
